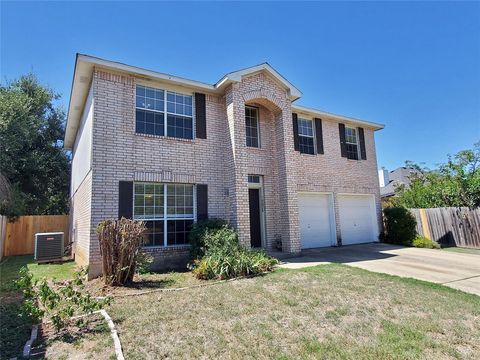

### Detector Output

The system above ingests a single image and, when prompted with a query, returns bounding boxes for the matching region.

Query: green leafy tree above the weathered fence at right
[393,142,480,208]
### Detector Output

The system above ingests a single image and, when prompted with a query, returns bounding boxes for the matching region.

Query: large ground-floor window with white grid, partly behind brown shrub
[133,182,195,246]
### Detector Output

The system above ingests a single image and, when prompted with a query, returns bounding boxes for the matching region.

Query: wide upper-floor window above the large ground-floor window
[135,85,193,139]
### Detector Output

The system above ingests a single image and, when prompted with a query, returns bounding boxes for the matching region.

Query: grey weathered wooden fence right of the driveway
[410,207,480,248]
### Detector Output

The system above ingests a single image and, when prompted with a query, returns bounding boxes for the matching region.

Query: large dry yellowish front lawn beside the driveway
[108,264,480,359]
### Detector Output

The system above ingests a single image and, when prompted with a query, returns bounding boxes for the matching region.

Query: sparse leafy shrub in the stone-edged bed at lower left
[15,267,111,331]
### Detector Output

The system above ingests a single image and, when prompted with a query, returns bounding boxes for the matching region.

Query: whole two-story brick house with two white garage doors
[65,55,383,276]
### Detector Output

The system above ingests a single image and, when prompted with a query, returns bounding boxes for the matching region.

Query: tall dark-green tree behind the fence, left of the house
[0,74,70,216]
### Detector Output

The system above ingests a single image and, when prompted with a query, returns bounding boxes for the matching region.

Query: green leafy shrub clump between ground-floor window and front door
[190,220,278,280]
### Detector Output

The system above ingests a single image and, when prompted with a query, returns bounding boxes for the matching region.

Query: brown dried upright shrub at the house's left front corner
[97,217,146,285]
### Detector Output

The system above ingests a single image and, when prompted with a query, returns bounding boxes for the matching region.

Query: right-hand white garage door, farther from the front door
[338,195,378,245]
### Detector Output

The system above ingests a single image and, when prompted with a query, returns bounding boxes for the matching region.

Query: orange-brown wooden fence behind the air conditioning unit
[3,215,68,256]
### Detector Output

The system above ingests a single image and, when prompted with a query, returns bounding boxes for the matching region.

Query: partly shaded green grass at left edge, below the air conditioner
[0,255,74,359]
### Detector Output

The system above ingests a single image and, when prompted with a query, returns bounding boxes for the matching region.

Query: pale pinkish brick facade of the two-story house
[69,68,380,276]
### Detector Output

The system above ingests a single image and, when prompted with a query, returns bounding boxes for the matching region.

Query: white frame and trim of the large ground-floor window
[132,181,197,249]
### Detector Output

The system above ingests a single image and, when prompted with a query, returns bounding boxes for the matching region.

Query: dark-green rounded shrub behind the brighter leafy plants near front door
[188,219,230,259]
